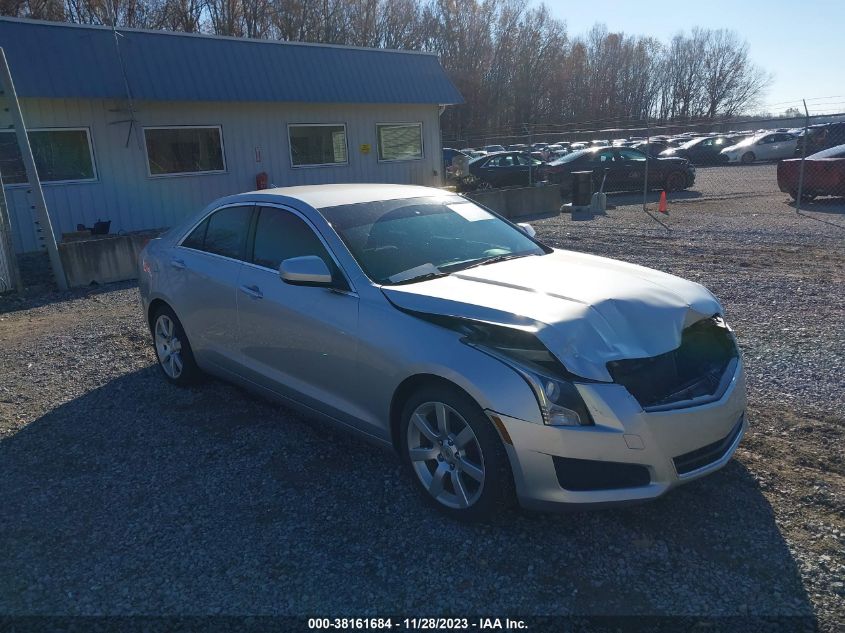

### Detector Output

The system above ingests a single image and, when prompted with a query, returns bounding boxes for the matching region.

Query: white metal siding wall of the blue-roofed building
[6,99,442,252]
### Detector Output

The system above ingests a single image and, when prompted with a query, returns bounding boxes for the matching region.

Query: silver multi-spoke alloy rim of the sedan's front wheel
[407,402,485,509]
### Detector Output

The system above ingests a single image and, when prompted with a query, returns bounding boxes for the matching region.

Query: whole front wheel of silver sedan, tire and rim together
[401,385,514,521]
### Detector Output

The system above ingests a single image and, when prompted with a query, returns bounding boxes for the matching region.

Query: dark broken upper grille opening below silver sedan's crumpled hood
[607,317,738,408]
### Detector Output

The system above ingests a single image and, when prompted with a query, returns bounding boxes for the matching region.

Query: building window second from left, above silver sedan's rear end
[144,125,226,176]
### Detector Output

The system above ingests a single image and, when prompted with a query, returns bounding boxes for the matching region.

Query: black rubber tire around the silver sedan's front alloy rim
[399,384,516,522]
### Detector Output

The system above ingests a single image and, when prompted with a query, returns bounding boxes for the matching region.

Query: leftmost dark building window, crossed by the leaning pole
[0,128,97,185]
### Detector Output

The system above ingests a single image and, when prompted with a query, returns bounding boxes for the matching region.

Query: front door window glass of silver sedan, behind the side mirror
[252,207,334,272]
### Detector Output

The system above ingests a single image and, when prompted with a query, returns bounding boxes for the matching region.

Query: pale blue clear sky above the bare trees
[545,0,845,115]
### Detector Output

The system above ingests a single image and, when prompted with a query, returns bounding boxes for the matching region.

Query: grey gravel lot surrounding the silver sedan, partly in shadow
[0,172,845,632]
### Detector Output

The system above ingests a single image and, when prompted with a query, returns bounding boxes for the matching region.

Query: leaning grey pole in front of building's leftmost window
[0,48,67,290]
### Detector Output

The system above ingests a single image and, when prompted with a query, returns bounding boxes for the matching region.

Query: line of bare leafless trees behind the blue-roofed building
[0,0,771,139]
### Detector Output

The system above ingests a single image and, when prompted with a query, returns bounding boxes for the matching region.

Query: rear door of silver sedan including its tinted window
[164,204,254,371]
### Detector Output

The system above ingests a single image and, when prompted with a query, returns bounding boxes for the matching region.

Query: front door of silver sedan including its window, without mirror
[237,207,360,424]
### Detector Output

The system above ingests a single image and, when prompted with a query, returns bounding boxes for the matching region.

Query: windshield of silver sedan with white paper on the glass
[320,195,550,285]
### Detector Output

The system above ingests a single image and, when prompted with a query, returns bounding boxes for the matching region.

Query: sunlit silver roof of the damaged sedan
[225,183,453,209]
